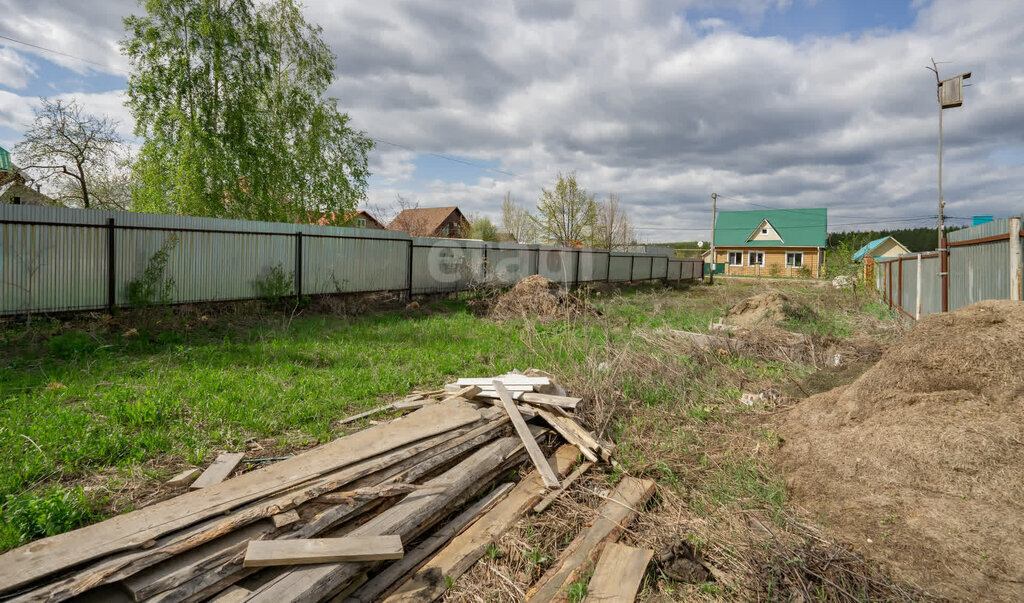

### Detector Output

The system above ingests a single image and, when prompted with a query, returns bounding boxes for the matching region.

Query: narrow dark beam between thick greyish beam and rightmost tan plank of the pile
[346,482,513,603]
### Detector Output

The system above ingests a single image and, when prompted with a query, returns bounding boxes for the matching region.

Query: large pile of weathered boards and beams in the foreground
[0,372,630,603]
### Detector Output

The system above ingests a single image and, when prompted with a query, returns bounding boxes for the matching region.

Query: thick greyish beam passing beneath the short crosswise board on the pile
[242,437,522,603]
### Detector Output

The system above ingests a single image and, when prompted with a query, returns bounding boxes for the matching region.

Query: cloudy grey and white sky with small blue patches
[0,0,1024,242]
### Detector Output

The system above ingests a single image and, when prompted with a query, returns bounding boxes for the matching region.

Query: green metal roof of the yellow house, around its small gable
[715,207,828,247]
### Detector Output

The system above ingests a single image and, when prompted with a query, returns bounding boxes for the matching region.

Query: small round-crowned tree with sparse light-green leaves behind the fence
[532,172,597,247]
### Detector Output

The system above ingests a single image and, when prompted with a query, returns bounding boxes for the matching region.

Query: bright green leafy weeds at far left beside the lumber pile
[0,486,95,550]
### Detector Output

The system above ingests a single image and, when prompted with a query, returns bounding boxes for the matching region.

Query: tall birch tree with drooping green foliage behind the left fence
[122,0,373,222]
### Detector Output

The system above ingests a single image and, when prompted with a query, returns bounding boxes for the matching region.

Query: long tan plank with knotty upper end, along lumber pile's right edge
[385,445,579,603]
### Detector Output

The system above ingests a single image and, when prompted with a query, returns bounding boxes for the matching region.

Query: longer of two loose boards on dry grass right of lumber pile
[526,477,654,602]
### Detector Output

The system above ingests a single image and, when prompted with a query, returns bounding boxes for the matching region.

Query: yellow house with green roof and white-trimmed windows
[715,208,828,277]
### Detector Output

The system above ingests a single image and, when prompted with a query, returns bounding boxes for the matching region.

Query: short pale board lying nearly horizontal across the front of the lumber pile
[242,535,404,567]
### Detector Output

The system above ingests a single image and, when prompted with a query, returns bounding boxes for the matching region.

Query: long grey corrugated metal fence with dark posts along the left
[0,205,703,314]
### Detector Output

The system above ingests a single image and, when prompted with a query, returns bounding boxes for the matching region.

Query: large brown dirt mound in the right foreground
[778,301,1024,600]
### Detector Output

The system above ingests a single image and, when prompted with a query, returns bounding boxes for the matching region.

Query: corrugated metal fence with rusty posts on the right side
[874,216,1024,318]
